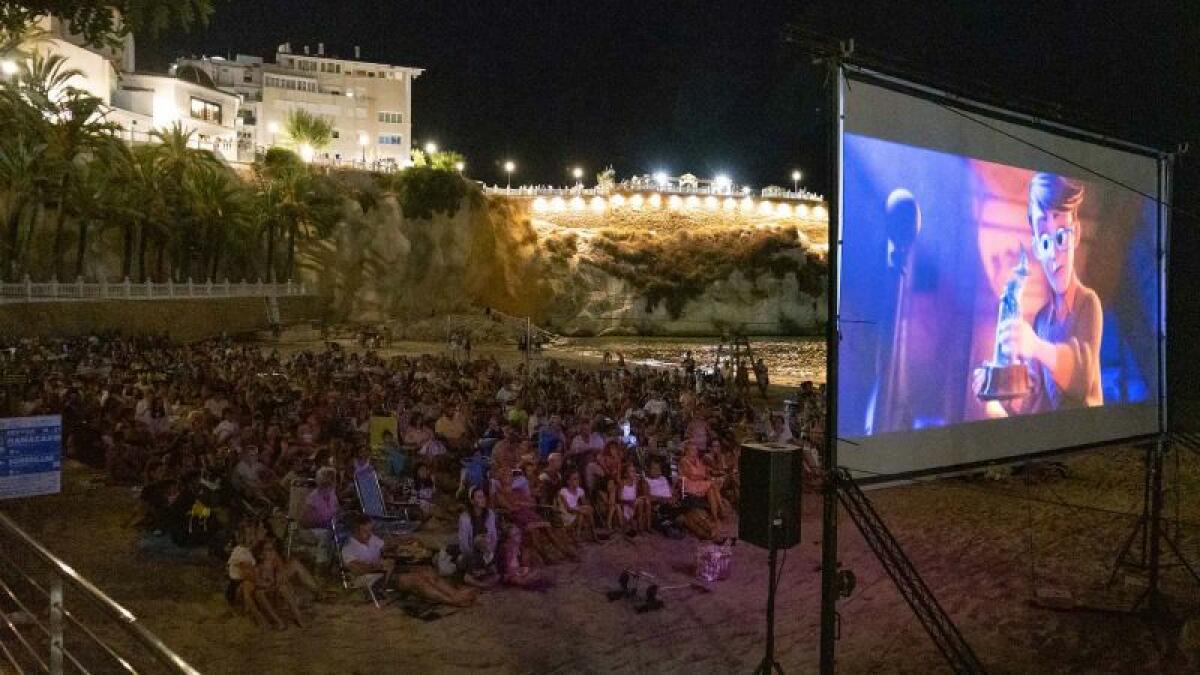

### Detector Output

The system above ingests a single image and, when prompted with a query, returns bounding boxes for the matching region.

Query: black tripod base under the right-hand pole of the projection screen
[1109,435,1200,614]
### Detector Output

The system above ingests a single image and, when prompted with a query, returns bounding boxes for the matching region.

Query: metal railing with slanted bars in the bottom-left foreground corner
[0,513,199,675]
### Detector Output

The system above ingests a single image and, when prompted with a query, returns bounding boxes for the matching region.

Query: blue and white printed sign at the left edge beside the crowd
[0,414,62,500]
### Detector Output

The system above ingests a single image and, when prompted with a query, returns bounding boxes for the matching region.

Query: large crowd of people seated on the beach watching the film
[0,335,823,627]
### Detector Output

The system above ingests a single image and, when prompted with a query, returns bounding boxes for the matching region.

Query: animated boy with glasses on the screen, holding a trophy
[976,173,1104,414]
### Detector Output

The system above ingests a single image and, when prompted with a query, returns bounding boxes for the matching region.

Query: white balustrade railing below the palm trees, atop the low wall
[0,276,312,303]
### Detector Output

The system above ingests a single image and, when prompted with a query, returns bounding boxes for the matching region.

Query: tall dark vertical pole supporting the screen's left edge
[821,47,853,675]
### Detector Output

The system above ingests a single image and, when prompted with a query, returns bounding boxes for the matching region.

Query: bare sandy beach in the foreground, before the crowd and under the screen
[5,439,1200,673]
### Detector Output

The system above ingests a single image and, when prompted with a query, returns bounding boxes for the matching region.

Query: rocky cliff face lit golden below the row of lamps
[306,197,824,335]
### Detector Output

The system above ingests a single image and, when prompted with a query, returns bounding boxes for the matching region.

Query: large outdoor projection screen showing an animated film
[836,70,1168,479]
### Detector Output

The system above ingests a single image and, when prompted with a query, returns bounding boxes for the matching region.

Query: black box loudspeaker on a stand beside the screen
[738,443,800,549]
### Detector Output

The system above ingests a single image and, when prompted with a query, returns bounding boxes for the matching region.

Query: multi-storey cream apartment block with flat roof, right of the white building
[173,43,425,168]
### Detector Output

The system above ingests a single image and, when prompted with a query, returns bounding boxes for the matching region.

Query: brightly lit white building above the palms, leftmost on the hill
[11,17,239,161]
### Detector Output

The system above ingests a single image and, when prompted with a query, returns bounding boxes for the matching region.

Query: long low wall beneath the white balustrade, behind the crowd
[0,297,318,342]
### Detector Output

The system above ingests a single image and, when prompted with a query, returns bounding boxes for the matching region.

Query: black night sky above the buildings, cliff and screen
[138,0,1200,398]
